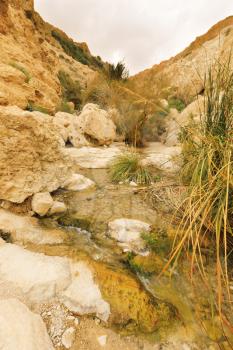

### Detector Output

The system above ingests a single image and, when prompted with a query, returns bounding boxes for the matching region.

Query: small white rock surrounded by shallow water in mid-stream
[108,218,151,252]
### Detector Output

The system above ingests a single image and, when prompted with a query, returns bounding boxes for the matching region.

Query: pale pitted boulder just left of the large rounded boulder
[54,112,89,147]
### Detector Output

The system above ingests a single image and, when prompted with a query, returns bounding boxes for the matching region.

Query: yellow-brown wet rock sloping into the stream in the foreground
[91,261,175,334]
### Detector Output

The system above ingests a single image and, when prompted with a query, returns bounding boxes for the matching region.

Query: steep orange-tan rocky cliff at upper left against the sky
[0,0,104,113]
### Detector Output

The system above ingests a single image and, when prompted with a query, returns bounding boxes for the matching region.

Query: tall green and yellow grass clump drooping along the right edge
[167,59,233,316]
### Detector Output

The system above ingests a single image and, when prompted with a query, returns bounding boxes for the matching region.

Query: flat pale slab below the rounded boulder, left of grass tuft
[67,146,121,169]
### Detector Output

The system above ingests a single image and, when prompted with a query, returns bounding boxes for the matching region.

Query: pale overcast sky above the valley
[34,0,233,74]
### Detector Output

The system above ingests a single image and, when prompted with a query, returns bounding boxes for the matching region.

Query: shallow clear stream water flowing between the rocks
[36,166,231,350]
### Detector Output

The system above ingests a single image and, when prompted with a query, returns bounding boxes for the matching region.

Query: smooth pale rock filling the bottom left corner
[0,299,54,350]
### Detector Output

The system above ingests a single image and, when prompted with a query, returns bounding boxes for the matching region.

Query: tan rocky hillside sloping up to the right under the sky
[129,16,233,103]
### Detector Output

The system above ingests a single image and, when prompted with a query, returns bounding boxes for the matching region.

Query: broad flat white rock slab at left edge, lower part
[0,244,71,303]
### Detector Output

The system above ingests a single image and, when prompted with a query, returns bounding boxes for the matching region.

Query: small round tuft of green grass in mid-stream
[110,150,153,185]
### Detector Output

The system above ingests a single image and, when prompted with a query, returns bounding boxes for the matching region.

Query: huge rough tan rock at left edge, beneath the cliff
[0,107,72,203]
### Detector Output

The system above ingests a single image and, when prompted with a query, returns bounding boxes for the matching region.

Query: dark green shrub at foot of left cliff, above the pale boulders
[58,70,82,109]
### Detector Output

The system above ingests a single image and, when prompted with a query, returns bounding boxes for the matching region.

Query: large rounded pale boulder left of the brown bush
[78,103,116,145]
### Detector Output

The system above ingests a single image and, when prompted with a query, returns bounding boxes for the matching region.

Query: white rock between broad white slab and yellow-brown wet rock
[61,262,110,321]
